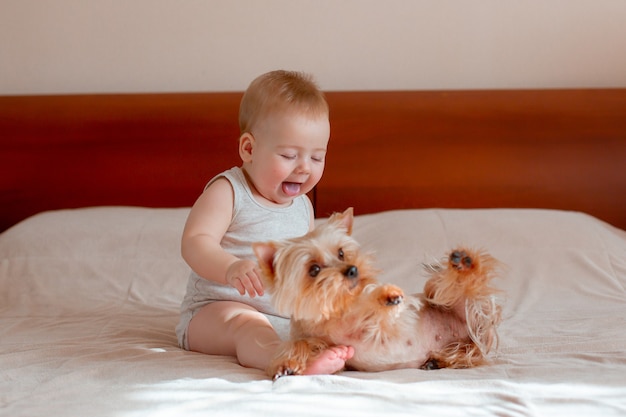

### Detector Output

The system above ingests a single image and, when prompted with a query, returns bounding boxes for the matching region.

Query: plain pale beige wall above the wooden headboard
[0,0,626,94]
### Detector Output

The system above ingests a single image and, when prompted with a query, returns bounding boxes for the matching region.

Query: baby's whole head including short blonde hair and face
[239,70,330,206]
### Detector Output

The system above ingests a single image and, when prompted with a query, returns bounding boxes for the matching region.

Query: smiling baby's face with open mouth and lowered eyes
[244,114,330,205]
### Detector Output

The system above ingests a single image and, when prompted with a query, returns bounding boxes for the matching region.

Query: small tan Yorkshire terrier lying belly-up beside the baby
[253,208,501,380]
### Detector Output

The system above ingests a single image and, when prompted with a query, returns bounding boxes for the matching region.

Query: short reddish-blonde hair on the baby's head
[239,70,328,134]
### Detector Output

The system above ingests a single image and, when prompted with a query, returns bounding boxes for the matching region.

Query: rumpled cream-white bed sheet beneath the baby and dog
[0,207,626,417]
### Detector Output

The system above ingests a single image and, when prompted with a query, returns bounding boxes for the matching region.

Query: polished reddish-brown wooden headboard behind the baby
[0,89,626,230]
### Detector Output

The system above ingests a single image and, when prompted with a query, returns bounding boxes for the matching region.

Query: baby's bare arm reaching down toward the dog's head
[181,178,263,297]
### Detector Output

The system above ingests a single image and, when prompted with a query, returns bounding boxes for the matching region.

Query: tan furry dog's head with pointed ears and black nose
[253,208,376,321]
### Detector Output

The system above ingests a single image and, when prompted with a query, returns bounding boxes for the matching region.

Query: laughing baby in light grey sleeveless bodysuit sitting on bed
[176,71,354,374]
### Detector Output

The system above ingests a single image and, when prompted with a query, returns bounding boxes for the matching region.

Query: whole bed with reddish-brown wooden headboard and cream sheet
[0,89,626,417]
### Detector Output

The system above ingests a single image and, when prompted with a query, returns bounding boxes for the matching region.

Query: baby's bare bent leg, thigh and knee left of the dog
[187,301,281,370]
